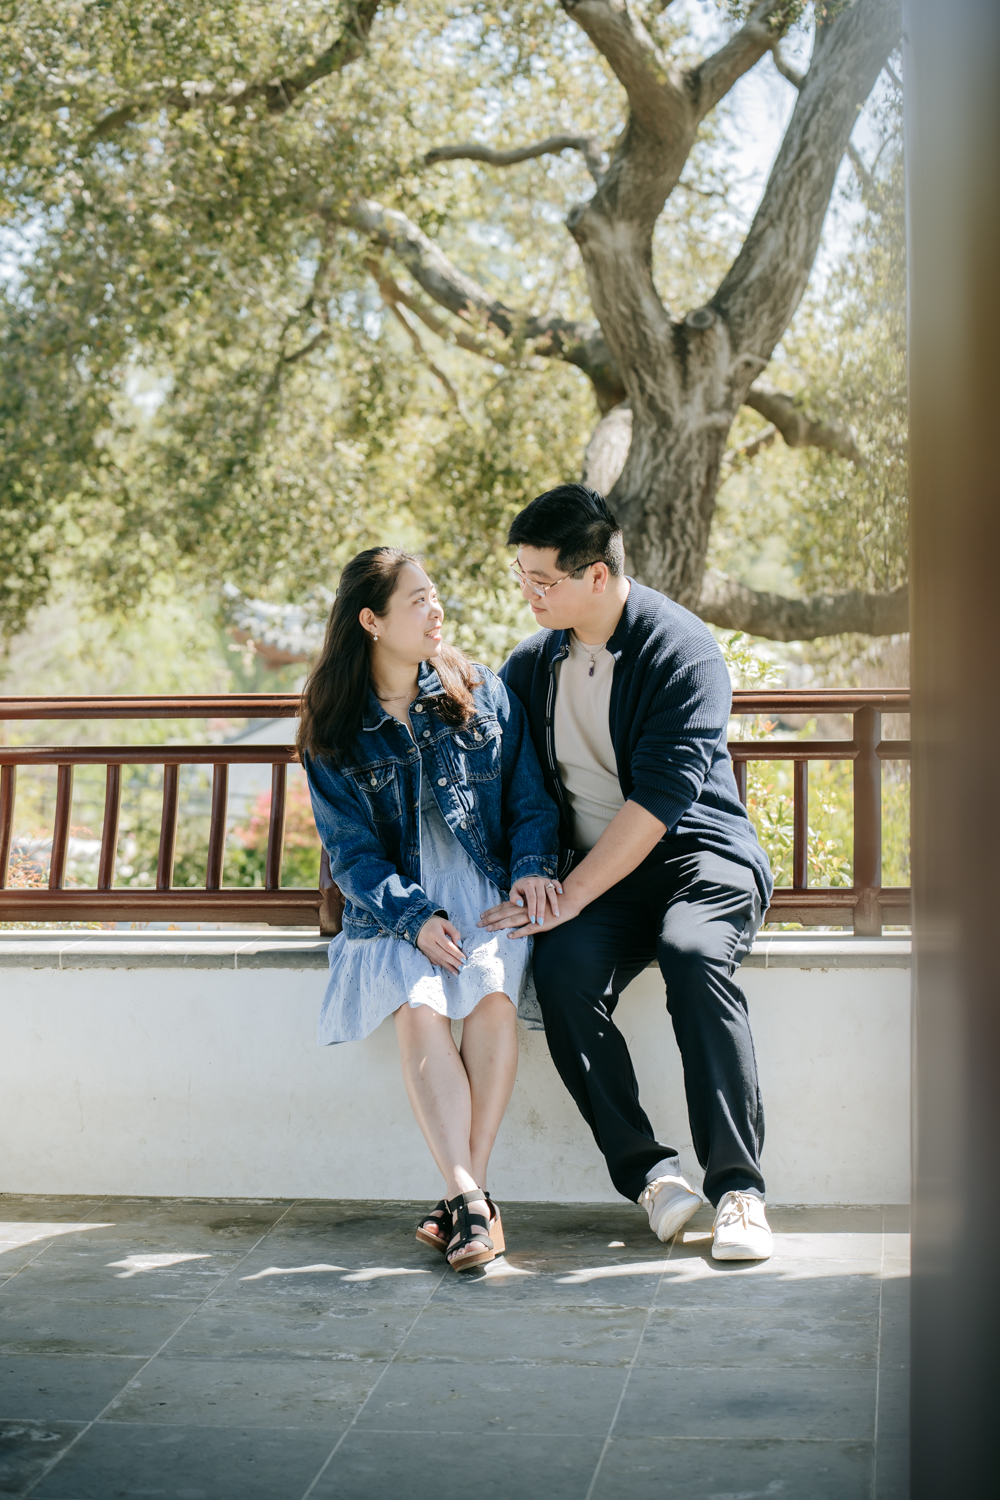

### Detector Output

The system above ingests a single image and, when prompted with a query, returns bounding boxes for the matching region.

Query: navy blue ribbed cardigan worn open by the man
[499,579,774,908]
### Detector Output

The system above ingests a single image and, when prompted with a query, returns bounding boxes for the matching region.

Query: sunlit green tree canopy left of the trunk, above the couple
[0,0,746,660]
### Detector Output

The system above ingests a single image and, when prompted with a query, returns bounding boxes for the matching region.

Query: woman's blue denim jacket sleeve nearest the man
[490,674,559,882]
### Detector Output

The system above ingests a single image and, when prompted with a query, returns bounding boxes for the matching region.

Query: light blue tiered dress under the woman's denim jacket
[319,762,541,1046]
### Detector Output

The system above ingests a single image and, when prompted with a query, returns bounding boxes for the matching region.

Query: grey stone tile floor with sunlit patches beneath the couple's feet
[0,1194,909,1500]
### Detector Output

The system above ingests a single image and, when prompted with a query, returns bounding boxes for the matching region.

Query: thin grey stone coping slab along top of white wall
[0,930,910,969]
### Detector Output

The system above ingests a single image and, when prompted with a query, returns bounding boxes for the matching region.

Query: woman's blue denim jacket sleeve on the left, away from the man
[303,755,438,948]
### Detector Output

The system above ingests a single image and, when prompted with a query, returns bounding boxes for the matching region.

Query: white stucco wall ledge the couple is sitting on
[0,927,910,1203]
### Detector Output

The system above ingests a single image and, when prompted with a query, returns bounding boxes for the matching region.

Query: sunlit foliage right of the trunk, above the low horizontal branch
[712,87,909,609]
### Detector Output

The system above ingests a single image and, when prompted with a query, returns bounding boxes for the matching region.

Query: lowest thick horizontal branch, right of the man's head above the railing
[697,569,910,641]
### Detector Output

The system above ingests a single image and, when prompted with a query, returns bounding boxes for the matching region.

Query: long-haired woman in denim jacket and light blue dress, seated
[298,548,559,1271]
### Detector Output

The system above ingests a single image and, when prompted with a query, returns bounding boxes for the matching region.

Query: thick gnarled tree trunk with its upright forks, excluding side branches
[564,0,898,609]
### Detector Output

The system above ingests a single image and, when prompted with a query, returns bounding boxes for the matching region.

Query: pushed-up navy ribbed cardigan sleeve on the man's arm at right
[628,653,732,830]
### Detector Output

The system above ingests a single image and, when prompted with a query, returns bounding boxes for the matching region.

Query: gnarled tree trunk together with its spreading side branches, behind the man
[371,0,903,635]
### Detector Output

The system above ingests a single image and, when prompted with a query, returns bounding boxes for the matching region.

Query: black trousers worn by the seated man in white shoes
[534,849,765,1203]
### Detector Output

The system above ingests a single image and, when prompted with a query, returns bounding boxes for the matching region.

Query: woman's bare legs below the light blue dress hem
[394,993,517,1254]
